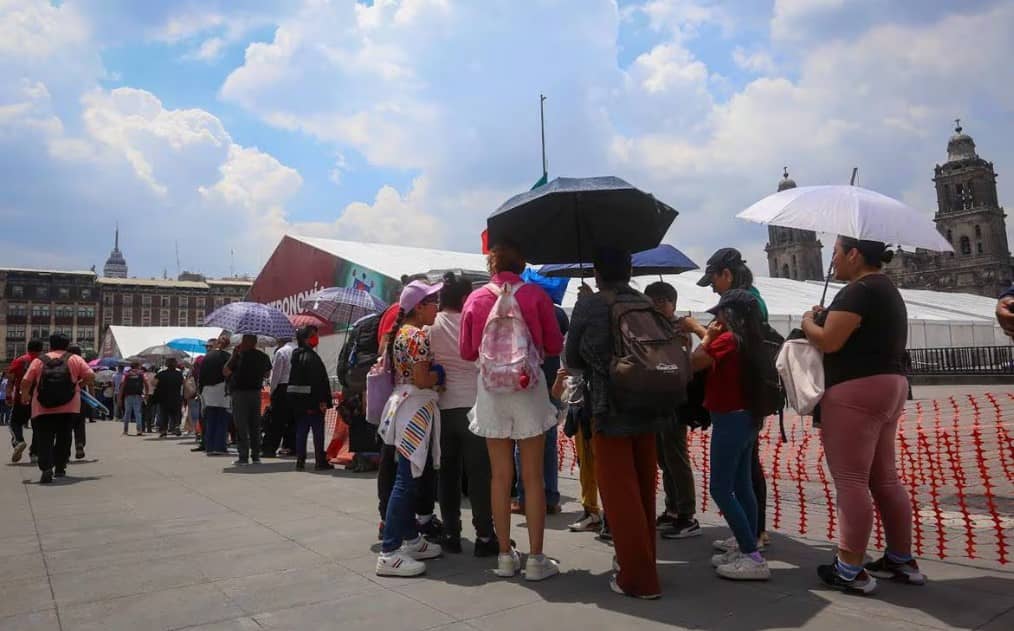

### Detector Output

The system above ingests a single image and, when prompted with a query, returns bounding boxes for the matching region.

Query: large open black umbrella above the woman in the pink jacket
[486,177,678,263]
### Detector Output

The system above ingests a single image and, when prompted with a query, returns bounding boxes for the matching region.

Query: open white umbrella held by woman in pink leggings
[736,185,954,252]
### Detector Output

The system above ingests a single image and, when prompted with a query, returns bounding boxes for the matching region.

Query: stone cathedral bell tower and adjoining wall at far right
[886,122,1014,296]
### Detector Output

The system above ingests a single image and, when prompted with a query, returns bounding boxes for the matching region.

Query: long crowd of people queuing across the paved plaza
[9,237,1014,600]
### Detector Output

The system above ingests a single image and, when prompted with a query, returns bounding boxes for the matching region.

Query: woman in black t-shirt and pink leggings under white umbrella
[803,236,925,593]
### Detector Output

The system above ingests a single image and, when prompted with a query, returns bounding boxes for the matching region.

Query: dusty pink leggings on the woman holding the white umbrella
[820,374,912,555]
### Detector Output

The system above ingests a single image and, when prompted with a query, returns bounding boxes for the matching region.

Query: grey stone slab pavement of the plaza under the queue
[0,422,1014,631]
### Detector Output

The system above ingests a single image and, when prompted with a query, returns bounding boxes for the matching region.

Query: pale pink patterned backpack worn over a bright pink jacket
[479,283,542,394]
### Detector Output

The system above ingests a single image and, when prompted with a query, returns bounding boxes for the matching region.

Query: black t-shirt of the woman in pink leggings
[824,274,909,388]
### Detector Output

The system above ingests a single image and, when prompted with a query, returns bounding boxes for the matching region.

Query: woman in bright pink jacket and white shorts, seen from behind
[459,243,563,580]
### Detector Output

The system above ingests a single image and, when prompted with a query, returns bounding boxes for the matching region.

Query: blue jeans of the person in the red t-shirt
[711,410,757,554]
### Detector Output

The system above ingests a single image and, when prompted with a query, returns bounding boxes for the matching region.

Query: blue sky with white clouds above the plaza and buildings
[0,0,1014,277]
